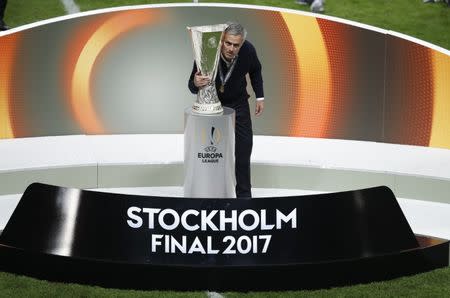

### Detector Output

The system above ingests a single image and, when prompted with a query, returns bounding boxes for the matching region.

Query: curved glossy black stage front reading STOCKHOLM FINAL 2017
[0,184,449,291]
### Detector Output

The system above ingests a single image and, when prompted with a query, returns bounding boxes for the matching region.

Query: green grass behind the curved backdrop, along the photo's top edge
[5,0,450,49]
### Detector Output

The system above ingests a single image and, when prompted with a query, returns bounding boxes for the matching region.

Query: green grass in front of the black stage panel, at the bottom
[0,268,450,297]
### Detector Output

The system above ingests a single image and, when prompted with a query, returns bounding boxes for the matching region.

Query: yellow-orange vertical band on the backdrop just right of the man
[282,13,332,138]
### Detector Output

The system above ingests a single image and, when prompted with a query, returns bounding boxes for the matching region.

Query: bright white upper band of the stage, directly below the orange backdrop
[0,134,450,177]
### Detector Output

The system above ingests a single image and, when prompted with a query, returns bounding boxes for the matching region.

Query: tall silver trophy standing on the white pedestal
[188,24,227,114]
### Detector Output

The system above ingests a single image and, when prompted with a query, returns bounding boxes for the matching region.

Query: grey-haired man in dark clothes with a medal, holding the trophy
[188,23,264,198]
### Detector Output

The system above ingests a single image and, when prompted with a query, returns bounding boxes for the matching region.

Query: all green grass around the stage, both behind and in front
[0,0,450,297]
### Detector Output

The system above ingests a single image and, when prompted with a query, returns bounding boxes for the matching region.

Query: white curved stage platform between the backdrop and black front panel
[0,134,450,239]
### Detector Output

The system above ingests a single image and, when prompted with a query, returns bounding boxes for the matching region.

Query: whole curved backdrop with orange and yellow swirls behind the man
[0,6,450,148]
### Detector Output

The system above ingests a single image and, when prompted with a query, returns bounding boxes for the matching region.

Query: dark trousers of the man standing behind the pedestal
[224,100,253,198]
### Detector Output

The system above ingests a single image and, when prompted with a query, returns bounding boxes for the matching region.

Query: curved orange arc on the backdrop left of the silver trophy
[65,10,159,134]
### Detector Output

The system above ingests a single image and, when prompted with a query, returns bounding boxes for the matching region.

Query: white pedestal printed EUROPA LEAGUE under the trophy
[184,107,236,198]
